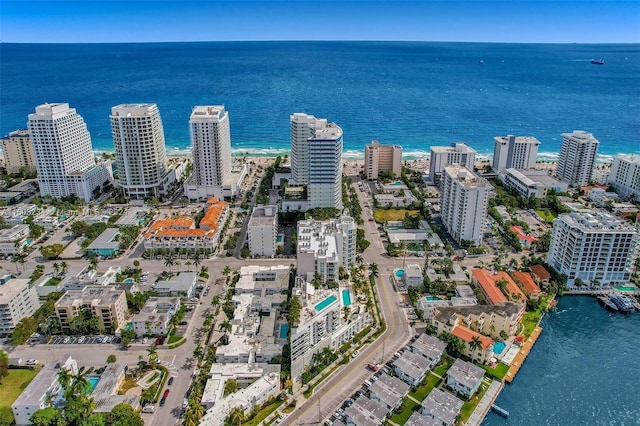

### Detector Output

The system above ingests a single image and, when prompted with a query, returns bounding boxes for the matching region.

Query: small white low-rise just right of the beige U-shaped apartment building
[131,297,180,337]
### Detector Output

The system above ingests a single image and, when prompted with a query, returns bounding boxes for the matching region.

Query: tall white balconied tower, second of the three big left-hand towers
[110,104,167,200]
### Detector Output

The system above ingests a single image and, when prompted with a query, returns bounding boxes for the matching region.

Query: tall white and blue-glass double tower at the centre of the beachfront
[291,113,342,209]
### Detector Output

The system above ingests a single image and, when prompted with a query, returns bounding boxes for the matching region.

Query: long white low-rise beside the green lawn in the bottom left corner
[11,355,78,426]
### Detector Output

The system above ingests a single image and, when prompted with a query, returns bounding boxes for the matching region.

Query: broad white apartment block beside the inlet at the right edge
[547,212,639,285]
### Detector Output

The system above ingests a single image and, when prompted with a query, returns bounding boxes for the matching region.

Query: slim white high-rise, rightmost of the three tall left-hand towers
[189,105,231,186]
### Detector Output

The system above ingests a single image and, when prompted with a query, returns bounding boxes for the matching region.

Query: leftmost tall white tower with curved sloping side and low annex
[28,103,111,201]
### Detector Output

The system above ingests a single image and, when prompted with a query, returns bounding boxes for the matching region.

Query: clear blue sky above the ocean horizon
[0,0,640,43]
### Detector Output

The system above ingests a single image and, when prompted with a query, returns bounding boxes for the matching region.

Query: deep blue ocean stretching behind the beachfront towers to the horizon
[0,42,640,161]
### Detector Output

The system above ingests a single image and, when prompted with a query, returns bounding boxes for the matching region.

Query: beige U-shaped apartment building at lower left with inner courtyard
[54,285,129,333]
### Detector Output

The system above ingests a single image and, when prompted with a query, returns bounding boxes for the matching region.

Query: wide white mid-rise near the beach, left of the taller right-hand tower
[492,135,540,173]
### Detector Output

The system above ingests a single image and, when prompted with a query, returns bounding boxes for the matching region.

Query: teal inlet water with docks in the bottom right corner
[483,296,640,426]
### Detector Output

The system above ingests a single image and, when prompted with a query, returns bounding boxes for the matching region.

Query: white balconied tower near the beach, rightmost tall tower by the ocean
[556,130,600,186]
